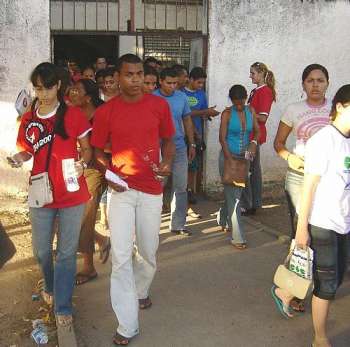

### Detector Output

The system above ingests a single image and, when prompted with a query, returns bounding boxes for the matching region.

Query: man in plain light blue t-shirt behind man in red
[153,68,196,236]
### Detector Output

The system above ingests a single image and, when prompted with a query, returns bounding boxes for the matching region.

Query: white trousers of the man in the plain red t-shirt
[107,189,162,337]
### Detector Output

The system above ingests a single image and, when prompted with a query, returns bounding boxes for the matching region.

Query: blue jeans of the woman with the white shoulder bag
[29,204,85,315]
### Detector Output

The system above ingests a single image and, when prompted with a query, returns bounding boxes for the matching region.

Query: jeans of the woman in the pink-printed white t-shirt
[284,169,304,239]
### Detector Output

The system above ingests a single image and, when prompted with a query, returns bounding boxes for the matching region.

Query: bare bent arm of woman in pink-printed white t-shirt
[273,122,304,172]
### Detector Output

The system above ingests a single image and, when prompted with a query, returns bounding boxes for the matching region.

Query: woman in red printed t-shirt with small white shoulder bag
[8,63,92,327]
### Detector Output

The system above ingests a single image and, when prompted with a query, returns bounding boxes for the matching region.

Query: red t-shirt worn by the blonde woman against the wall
[248,85,273,144]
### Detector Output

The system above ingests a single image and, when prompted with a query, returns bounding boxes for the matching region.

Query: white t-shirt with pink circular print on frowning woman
[281,100,332,157]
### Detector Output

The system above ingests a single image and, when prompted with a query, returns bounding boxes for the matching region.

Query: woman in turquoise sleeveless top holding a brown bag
[218,84,259,250]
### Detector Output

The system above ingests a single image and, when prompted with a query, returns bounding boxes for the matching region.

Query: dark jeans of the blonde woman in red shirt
[241,145,262,210]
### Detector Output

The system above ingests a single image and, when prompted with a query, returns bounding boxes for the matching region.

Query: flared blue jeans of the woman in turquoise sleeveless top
[217,151,246,243]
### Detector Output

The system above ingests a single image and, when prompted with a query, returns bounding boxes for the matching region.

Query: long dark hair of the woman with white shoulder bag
[30,63,68,139]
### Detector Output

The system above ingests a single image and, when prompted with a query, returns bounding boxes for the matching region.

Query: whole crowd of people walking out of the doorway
[6,54,350,347]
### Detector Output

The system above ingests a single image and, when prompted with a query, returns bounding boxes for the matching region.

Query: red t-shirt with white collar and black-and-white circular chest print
[17,107,91,208]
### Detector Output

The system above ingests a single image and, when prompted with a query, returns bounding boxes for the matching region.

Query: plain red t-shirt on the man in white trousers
[91,94,175,194]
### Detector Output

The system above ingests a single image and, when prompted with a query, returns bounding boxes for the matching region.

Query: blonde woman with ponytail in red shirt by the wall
[242,62,276,215]
